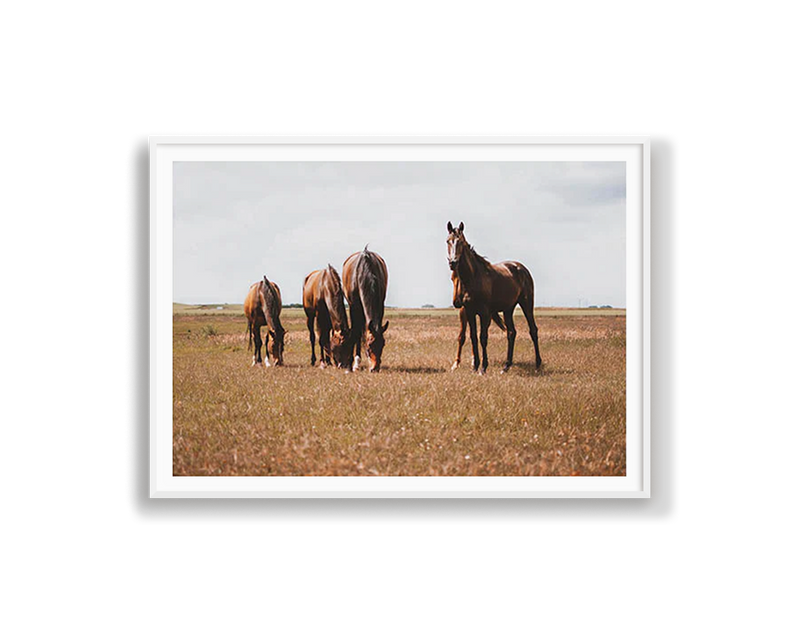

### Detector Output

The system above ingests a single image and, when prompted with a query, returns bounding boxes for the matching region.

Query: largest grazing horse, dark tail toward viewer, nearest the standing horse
[342,247,389,373]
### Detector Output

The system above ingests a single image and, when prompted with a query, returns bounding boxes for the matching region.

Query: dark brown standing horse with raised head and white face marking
[447,222,542,373]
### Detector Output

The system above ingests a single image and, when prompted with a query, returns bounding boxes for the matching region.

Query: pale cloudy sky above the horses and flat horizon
[173,161,626,307]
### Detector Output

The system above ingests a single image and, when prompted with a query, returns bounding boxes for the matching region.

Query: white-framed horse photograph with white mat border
[149,129,658,500]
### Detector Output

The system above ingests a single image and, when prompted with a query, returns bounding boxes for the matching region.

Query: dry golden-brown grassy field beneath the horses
[173,304,626,476]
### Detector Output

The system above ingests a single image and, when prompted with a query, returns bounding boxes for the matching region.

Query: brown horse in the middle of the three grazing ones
[303,265,353,369]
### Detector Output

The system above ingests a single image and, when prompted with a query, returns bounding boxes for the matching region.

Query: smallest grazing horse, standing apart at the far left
[244,276,286,367]
